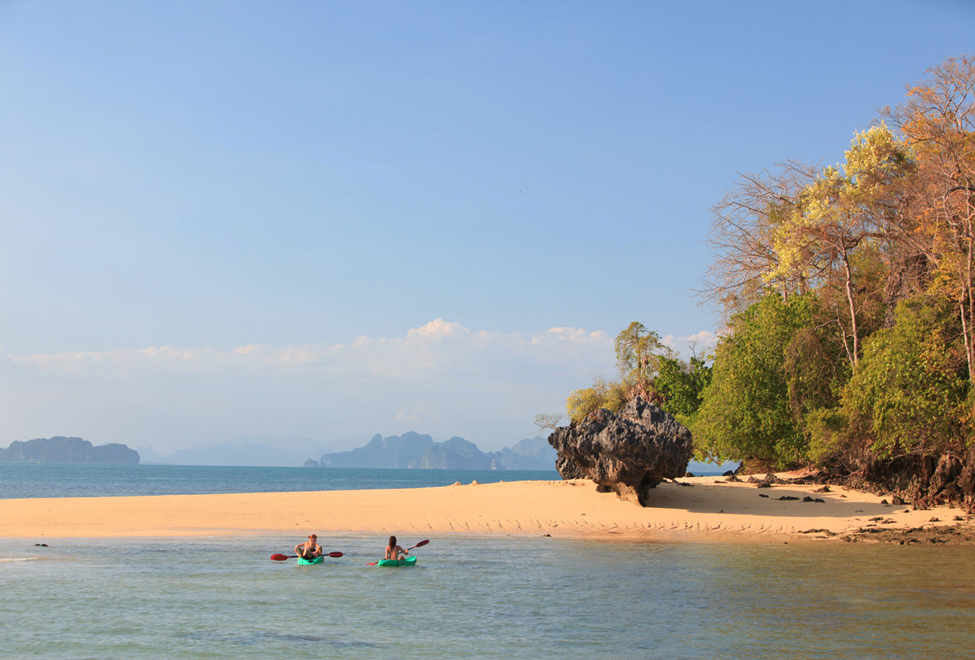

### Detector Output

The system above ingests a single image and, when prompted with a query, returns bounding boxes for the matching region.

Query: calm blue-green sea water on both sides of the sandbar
[0,463,975,660]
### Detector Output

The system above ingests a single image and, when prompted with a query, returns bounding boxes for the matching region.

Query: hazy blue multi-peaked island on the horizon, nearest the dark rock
[305,431,555,470]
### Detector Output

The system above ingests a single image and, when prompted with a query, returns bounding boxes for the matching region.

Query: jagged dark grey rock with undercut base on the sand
[548,397,692,506]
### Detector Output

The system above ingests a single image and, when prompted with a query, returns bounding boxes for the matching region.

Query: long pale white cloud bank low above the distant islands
[0,319,614,454]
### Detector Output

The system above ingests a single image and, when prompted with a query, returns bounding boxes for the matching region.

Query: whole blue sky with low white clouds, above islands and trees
[0,0,975,453]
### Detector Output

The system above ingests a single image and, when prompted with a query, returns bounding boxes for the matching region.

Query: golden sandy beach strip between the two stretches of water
[0,477,975,543]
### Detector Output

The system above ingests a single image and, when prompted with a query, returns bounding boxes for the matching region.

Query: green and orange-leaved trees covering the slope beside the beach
[552,56,975,510]
